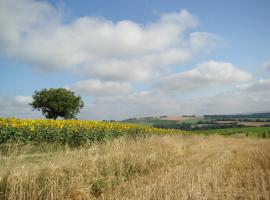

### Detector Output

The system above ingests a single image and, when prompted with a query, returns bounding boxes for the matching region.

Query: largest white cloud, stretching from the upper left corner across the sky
[0,0,216,81]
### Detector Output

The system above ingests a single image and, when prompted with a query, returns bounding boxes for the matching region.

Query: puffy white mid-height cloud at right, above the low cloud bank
[159,61,252,91]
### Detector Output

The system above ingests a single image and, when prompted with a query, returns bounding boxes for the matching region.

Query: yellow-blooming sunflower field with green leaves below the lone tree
[0,118,182,146]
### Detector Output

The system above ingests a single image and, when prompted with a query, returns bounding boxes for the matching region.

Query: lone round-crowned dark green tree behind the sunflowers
[29,88,84,119]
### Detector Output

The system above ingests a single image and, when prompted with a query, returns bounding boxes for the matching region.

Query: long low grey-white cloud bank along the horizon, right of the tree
[77,79,270,119]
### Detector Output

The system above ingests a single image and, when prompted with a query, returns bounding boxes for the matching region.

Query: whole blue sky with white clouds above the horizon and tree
[0,0,270,120]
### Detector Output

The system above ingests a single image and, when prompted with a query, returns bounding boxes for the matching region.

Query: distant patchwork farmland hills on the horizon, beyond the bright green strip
[122,113,270,133]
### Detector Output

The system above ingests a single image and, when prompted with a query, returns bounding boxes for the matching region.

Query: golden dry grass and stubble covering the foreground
[0,136,270,200]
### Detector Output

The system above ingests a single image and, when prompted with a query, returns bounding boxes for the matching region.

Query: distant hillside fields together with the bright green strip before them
[122,114,270,134]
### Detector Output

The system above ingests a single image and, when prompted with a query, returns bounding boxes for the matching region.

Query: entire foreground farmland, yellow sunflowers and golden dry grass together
[0,118,270,200]
